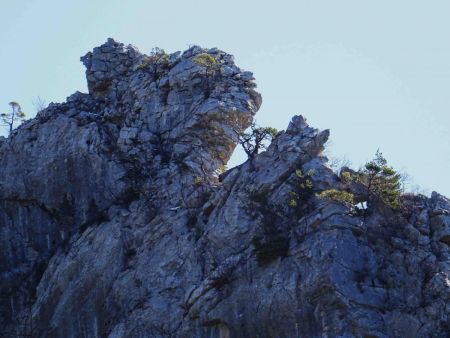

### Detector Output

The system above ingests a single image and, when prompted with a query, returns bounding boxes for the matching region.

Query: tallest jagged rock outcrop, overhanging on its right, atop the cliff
[81,39,262,169]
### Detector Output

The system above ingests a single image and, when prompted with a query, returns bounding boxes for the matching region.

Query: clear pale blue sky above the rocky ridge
[0,0,450,196]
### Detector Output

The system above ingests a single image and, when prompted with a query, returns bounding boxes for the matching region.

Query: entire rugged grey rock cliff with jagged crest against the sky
[0,39,450,338]
